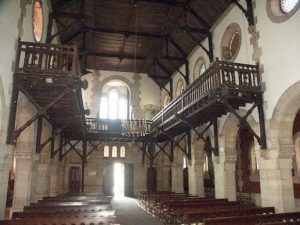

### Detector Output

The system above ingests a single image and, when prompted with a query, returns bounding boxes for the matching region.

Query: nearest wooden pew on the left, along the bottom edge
[0,216,116,225]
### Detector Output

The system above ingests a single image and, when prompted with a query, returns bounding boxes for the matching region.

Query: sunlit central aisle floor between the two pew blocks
[111,197,163,225]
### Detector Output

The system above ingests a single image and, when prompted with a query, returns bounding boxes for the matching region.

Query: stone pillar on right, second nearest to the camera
[214,152,236,201]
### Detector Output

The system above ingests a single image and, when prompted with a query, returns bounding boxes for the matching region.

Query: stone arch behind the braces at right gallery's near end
[219,109,258,159]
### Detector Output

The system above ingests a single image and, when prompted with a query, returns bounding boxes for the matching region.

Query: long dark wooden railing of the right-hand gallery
[151,60,261,130]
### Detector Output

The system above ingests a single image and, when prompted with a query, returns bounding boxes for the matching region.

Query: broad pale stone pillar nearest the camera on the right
[257,150,295,212]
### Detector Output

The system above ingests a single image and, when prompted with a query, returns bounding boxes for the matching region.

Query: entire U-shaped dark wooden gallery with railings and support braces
[7,42,265,150]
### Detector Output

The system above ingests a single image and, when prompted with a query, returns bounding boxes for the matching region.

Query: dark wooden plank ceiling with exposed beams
[51,0,232,86]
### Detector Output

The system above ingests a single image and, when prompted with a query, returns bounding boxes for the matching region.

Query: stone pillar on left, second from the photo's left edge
[12,152,32,212]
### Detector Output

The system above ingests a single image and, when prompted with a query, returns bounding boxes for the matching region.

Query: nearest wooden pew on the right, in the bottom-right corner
[204,212,300,225]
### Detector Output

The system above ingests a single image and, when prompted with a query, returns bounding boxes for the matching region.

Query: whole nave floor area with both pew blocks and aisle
[0,192,300,225]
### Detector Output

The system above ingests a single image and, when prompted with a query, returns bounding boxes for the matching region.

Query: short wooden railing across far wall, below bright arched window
[86,118,151,135]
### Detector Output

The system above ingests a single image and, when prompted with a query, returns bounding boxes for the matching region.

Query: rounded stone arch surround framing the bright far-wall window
[94,75,137,116]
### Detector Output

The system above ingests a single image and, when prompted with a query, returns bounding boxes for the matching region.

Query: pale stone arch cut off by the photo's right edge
[268,81,300,158]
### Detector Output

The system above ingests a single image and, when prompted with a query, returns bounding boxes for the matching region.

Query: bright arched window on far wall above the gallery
[100,80,131,119]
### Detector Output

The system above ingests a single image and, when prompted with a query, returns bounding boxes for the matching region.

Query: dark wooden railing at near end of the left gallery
[15,41,79,76]
